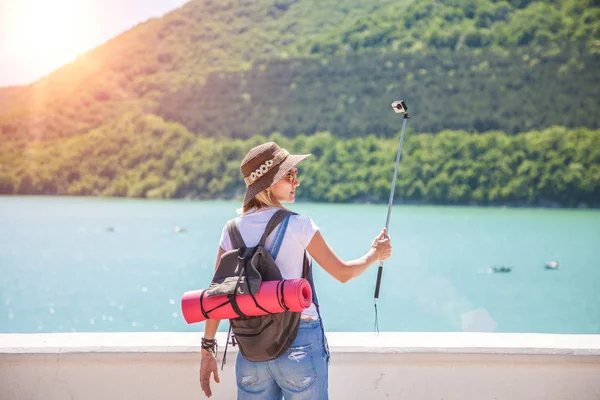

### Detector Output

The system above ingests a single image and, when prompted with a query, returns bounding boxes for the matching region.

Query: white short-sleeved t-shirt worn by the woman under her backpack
[220,207,319,319]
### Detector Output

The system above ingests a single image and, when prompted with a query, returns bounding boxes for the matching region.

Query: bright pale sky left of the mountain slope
[0,0,188,86]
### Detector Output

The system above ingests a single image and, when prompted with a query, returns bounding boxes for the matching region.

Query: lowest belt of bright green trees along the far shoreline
[0,114,600,207]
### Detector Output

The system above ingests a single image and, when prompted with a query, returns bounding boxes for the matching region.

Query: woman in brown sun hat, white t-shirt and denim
[200,142,392,400]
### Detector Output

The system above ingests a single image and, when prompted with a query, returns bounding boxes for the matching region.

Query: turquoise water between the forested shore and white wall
[0,197,600,333]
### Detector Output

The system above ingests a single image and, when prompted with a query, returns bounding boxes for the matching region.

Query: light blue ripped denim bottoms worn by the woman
[235,319,329,400]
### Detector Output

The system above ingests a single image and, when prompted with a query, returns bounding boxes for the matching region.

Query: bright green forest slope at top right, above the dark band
[292,0,600,54]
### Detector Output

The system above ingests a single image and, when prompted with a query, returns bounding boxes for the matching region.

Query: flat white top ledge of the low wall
[0,332,600,357]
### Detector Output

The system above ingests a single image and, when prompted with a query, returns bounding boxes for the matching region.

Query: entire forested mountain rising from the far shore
[0,0,600,206]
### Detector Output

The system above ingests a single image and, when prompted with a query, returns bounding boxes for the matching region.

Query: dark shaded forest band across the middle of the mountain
[156,50,600,138]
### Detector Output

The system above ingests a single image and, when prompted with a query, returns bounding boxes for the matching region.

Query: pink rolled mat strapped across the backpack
[181,279,312,324]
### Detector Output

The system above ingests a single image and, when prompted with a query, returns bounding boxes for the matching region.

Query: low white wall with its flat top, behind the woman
[0,333,600,400]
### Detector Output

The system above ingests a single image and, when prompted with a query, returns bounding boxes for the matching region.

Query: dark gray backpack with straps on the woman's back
[203,210,310,364]
